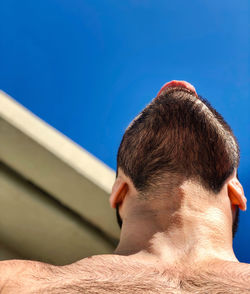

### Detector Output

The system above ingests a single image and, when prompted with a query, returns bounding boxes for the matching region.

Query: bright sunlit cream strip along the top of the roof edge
[0,91,115,193]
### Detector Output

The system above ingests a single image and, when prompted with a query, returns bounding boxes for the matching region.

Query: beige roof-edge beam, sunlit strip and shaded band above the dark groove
[0,91,119,238]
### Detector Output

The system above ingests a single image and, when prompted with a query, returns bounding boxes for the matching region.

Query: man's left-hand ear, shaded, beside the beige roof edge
[109,177,128,208]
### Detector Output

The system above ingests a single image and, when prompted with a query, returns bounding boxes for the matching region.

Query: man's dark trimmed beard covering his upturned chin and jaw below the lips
[117,87,239,194]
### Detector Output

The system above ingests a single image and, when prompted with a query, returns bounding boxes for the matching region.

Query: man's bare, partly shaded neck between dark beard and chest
[115,184,237,264]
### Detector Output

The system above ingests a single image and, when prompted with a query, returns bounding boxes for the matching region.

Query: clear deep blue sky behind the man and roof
[0,0,250,262]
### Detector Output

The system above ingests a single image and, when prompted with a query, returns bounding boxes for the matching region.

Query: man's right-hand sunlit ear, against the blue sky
[228,177,247,210]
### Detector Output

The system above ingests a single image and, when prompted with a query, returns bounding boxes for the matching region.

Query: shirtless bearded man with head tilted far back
[0,81,250,294]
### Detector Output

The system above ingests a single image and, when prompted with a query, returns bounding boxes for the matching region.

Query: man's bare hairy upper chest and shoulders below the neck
[0,255,250,294]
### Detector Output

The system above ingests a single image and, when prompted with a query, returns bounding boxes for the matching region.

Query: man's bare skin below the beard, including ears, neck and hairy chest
[0,170,250,294]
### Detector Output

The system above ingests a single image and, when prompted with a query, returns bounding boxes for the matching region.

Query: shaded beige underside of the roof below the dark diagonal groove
[0,164,114,265]
